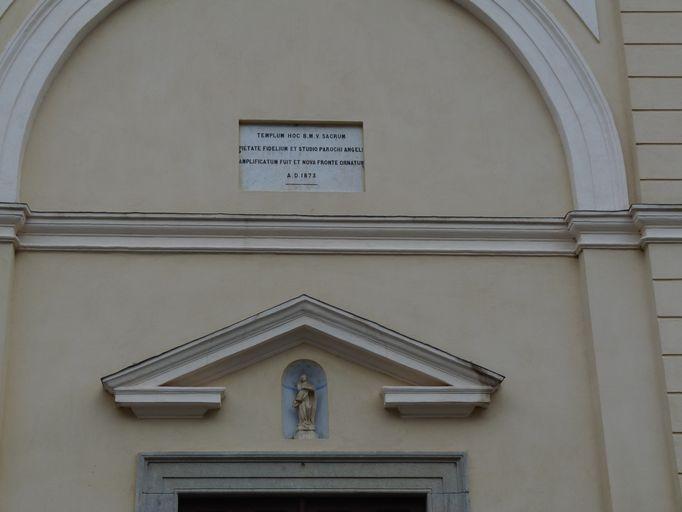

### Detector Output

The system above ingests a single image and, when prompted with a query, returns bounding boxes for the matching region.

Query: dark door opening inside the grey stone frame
[178,494,426,512]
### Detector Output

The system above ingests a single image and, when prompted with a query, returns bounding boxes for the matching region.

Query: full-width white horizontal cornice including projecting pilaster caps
[0,203,682,256]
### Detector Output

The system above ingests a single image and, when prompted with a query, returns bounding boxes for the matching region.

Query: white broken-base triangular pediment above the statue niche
[102,295,504,418]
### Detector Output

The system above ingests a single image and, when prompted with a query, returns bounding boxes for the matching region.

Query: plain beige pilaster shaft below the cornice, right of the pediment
[580,249,680,512]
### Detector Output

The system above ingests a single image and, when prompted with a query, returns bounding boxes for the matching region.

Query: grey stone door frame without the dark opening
[135,452,469,512]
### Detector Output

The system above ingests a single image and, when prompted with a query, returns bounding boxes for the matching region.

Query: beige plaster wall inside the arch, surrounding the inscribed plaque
[21,0,572,215]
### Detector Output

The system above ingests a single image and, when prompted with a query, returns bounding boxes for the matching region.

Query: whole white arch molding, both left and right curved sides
[0,0,629,211]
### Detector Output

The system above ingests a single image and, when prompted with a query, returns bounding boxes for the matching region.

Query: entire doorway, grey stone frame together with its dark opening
[135,452,469,512]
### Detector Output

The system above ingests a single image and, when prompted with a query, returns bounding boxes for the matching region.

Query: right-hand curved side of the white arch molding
[458,0,629,211]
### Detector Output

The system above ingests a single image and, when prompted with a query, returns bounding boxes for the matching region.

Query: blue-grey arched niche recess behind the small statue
[282,359,329,439]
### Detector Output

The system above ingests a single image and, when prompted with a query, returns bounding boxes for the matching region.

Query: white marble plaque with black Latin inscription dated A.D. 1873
[239,123,365,192]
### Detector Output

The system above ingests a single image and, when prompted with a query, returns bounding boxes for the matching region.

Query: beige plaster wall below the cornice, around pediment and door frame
[0,253,604,512]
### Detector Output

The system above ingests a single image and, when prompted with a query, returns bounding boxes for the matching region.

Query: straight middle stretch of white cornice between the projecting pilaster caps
[14,209,575,256]
